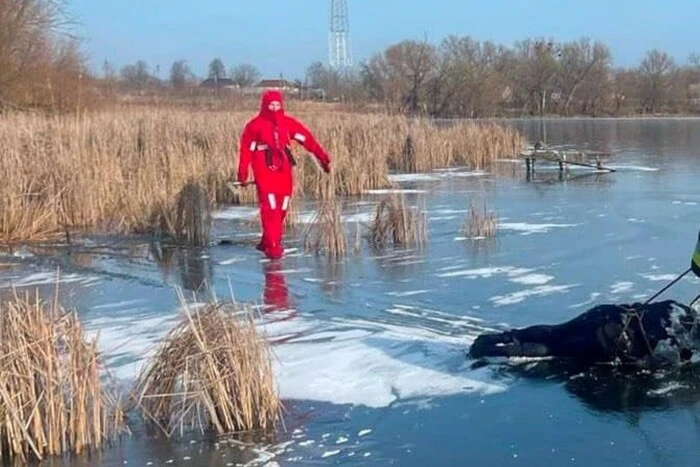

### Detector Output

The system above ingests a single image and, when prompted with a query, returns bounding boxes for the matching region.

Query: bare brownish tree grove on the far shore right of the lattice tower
[307,36,700,117]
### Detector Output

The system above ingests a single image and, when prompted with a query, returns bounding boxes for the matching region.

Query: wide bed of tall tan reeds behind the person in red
[0,107,525,242]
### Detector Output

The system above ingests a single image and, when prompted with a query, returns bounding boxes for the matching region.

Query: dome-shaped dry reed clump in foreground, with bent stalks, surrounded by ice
[135,300,281,436]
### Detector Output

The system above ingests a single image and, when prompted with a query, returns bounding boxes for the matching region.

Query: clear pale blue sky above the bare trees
[73,0,700,79]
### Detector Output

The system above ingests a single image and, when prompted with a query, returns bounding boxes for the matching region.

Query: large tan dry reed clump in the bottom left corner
[0,292,123,462]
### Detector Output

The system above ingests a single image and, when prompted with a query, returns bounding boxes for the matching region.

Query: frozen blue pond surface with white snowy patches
[0,119,700,466]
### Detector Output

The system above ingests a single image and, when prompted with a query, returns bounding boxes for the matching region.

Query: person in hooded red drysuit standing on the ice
[238,90,330,259]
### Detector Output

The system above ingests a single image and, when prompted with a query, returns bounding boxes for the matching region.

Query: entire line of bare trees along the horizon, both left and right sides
[0,0,700,118]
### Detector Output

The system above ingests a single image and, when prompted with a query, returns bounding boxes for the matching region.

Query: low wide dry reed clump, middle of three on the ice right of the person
[368,194,428,247]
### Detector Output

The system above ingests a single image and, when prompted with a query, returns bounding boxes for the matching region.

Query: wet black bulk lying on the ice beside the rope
[469,300,700,364]
